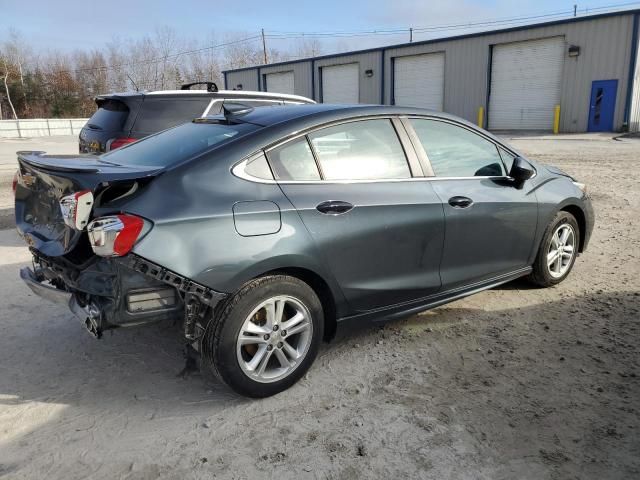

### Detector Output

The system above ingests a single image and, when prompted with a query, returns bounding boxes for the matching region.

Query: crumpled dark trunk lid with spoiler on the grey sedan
[15,152,162,257]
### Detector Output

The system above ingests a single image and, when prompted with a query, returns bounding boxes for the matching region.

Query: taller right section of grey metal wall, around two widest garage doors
[385,15,633,132]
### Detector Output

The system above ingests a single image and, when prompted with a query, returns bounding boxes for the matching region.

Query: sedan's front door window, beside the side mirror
[411,119,505,177]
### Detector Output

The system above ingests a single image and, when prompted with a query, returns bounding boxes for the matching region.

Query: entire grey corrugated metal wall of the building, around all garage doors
[222,13,640,132]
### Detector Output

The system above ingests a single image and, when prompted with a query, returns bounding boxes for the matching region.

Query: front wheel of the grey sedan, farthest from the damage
[529,211,580,287]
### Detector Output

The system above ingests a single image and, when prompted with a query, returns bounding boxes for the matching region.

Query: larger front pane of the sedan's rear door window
[309,119,411,180]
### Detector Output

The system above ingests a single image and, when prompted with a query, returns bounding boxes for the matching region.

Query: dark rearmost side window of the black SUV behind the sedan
[133,95,211,134]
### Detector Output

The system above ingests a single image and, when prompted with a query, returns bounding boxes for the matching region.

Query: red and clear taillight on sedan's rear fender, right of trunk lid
[87,214,144,257]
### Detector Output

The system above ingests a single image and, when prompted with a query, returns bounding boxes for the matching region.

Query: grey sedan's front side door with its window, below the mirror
[409,118,538,289]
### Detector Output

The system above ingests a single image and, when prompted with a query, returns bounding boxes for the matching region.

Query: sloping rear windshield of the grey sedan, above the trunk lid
[101,122,258,167]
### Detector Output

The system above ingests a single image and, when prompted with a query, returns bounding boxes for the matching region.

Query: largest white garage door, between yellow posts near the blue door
[489,37,565,130]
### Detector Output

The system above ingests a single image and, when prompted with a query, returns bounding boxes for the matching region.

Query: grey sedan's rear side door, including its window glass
[267,118,444,311]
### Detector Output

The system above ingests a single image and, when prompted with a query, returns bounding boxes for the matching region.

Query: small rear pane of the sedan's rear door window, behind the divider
[269,137,320,181]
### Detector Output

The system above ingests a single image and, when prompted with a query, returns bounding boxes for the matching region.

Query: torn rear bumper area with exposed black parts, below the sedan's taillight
[20,249,226,341]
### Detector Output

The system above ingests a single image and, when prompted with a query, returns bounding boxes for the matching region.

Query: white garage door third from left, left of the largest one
[393,53,444,111]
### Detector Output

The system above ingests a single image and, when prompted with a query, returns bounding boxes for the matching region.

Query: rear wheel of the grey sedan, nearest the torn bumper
[200,275,324,398]
